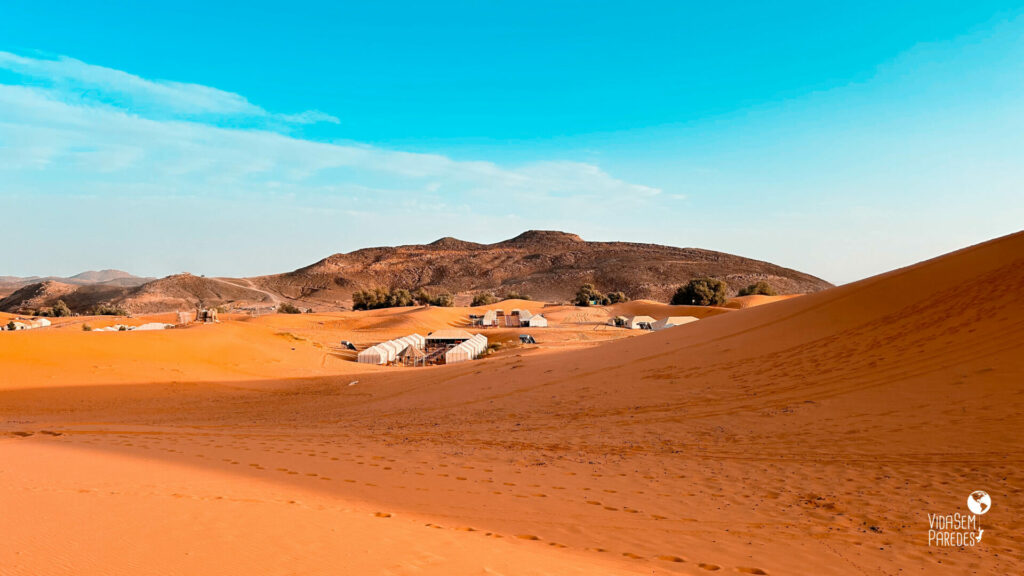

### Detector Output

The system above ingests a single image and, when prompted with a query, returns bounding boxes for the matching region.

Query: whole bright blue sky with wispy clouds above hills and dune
[0,2,1024,283]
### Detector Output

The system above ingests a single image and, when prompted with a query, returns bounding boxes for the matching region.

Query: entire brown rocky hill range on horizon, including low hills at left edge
[0,231,831,314]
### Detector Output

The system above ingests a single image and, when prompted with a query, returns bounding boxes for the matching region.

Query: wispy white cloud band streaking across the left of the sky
[0,52,659,211]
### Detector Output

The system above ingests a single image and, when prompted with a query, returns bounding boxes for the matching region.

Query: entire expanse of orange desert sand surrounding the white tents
[0,234,1024,575]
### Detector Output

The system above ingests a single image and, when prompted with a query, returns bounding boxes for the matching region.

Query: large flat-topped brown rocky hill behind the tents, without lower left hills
[253,231,831,304]
